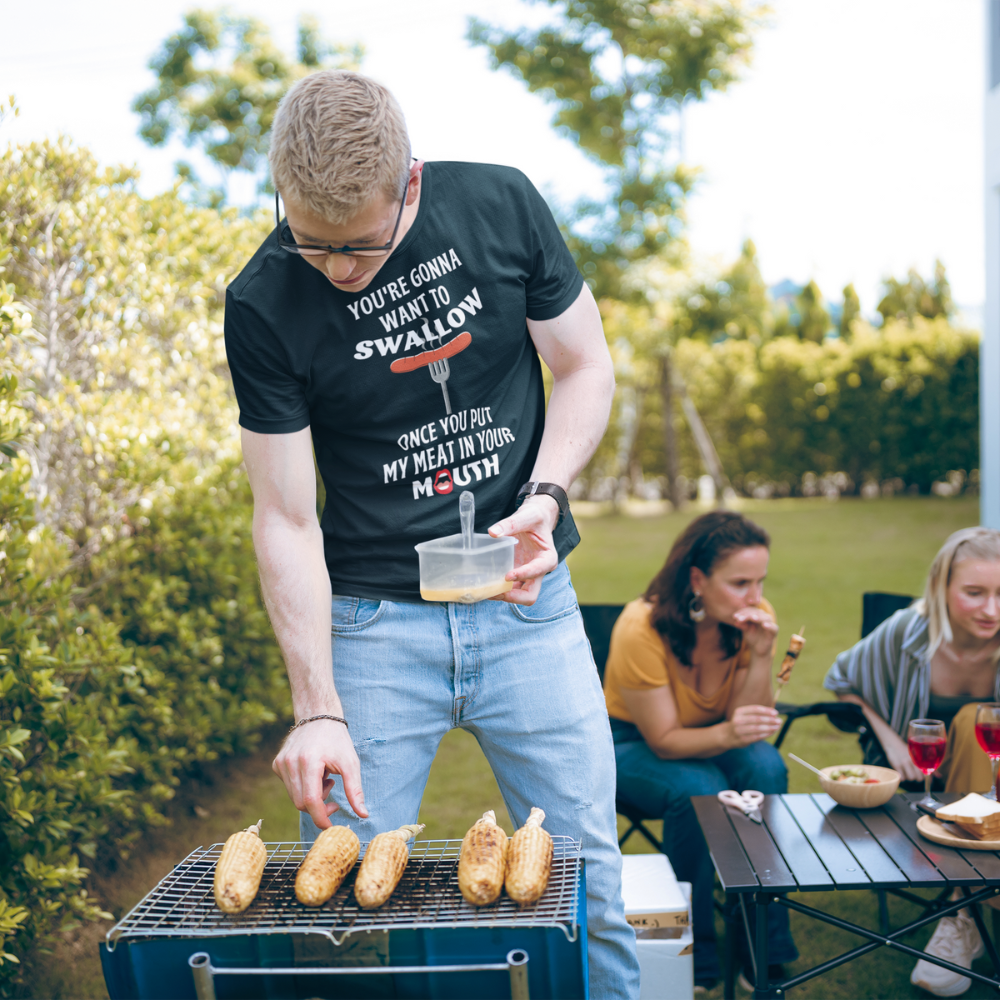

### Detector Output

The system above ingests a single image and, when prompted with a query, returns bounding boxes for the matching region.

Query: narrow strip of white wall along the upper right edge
[979,0,1000,528]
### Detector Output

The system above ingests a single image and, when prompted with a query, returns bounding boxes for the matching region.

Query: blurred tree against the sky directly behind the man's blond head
[132,10,363,200]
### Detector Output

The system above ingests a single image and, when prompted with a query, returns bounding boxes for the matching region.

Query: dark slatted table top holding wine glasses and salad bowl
[691,793,1000,893]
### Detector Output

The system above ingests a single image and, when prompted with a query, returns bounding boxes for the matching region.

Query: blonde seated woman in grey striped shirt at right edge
[823,528,1000,996]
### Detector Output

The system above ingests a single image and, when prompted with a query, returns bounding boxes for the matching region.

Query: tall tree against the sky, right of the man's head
[469,0,765,502]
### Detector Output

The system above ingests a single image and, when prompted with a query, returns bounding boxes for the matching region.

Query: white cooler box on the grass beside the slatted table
[622,854,694,1000]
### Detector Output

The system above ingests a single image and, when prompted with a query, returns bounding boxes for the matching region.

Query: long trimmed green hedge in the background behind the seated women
[624,317,979,493]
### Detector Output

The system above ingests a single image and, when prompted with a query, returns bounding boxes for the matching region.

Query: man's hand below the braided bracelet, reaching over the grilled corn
[271,719,368,830]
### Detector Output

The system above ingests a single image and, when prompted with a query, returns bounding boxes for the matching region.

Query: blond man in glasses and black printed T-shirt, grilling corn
[226,71,638,998]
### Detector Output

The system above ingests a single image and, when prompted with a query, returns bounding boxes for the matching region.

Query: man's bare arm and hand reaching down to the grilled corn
[242,428,368,829]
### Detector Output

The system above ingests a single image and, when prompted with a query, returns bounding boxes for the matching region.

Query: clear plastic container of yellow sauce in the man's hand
[414,533,516,604]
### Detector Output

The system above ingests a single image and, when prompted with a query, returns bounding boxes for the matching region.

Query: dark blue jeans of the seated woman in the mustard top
[611,719,799,981]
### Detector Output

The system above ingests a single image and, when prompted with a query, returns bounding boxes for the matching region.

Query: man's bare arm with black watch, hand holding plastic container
[490,285,615,604]
